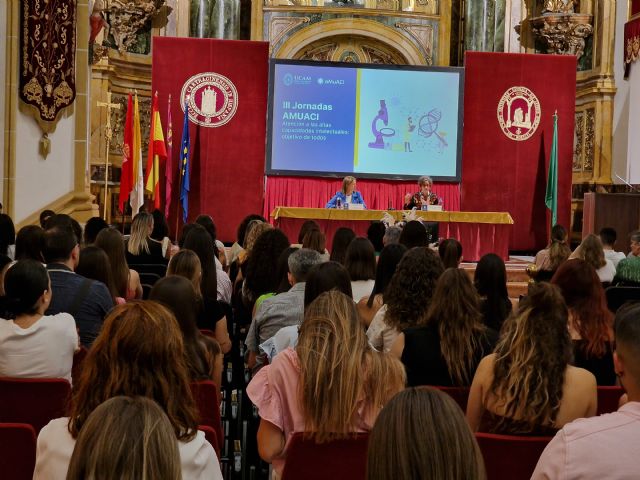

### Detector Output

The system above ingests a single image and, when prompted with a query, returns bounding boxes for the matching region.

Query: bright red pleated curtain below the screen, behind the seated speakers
[264,176,460,218]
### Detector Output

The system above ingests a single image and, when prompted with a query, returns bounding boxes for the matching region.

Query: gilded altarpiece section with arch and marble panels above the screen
[251,0,451,65]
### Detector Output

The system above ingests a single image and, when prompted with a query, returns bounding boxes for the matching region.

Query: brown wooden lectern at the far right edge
[582,193,640,253]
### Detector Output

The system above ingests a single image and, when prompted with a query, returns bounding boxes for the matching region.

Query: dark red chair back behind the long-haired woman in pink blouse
[282,433,369,480]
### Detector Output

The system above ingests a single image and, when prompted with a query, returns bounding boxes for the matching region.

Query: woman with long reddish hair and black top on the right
[551,259,616,385]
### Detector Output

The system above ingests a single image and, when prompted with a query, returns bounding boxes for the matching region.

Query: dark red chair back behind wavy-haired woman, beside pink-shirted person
[476,433,552,480]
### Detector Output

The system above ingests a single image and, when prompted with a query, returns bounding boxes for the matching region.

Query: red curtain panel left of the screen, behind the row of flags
[152,37,269,241]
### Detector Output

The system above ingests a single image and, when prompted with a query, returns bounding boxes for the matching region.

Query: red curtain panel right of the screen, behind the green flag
[461,52,576,250]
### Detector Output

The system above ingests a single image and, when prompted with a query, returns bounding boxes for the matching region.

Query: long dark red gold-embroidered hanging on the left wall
[19,0,77,132]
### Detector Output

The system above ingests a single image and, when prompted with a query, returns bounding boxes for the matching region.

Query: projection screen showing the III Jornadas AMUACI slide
[267,60,463,181]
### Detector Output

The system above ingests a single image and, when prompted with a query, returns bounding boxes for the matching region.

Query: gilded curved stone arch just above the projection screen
[274,18,427,65]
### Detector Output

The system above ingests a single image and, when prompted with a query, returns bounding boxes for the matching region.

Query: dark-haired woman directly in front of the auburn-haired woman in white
[149,275,222,387]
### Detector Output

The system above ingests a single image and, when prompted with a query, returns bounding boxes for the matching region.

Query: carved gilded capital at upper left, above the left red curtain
[103,0,165,52]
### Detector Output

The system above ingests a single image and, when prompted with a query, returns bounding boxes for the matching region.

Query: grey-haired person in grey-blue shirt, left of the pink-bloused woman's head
[245,248,321,368]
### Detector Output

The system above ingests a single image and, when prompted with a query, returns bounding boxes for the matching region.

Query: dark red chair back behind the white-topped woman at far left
[0,377,71,434]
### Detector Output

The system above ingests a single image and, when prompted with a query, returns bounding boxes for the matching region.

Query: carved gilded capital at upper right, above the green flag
[530,13,593,59]
